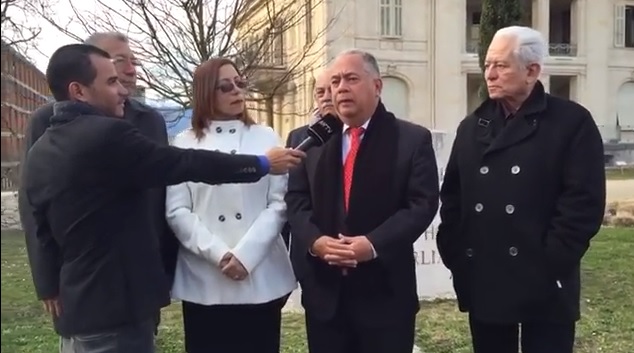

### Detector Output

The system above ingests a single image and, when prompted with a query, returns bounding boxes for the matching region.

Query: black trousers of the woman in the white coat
[183,299,282,353]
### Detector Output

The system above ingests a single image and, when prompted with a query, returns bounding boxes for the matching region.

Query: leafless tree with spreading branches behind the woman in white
[33,0,340,125]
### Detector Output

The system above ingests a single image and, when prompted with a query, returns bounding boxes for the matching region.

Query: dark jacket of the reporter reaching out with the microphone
[23,102,268,336]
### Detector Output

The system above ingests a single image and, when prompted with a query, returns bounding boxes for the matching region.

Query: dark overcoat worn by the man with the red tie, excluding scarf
[286,120,439,325]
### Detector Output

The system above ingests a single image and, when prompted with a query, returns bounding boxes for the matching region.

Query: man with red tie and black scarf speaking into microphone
[286,50,439,353]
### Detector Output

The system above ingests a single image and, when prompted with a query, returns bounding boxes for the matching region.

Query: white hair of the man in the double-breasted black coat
[493,26,548,67]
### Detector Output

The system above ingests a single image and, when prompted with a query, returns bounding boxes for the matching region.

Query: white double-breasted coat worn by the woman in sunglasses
[166,120,297,305]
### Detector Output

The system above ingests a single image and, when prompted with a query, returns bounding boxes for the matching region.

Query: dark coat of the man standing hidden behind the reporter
[18,100,178,305]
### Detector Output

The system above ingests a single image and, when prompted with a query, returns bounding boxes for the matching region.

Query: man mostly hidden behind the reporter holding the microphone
[18,32,178,334]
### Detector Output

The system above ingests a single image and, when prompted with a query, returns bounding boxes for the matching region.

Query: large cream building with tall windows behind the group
[240,0,634,142]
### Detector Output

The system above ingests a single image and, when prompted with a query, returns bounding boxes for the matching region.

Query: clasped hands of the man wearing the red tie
[311,234,375,268]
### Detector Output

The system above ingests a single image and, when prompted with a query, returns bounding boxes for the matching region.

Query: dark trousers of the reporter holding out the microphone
[59,319,156,353]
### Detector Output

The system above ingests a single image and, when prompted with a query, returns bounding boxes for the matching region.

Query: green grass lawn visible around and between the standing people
[1,228,634,353]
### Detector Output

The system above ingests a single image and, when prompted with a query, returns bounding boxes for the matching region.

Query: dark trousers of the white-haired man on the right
[469,317,575,353]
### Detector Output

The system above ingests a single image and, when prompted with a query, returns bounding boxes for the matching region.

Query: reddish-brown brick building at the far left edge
[2,41,50,191]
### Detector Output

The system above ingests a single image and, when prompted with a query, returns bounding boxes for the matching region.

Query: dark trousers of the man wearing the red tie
[306,286,416,353]
